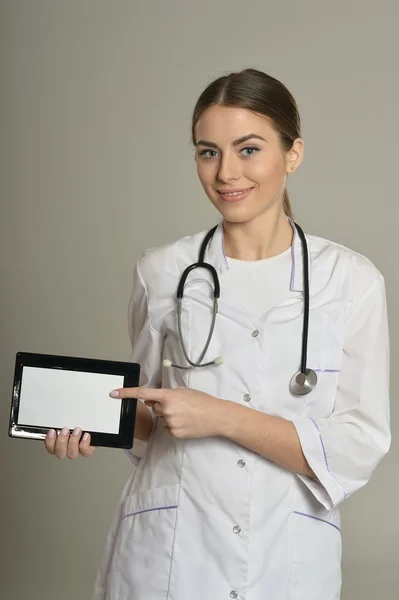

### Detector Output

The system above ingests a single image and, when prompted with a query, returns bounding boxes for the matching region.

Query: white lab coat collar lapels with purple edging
[205,217,312,292]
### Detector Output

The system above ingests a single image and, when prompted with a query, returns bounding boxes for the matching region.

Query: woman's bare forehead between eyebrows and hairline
[195,105,277,143]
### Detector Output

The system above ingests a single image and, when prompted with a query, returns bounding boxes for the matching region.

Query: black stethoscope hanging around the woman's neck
[163,223,317,396]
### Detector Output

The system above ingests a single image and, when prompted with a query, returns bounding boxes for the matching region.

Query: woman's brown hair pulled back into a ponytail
[191,69,301,218]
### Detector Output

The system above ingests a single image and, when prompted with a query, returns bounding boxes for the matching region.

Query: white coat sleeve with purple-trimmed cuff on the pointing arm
[293,277,391,509]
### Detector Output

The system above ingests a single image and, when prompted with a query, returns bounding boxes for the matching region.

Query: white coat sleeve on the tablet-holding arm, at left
[126,261,164,465]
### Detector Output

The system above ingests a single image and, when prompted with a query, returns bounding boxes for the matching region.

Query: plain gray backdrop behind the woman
[0,0,399,600]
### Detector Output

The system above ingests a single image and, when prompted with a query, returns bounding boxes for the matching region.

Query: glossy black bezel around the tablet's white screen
[8,352,140,449]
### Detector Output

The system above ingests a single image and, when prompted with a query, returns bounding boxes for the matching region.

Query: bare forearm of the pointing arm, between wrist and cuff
[220,401,315,478]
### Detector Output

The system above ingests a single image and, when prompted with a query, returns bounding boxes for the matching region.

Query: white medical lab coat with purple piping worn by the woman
[94,224,390,600]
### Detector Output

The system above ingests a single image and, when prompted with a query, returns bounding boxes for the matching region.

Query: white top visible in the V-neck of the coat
[223,249,293,318]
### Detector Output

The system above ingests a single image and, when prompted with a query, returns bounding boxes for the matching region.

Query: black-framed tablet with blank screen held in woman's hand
[9,352,140,448]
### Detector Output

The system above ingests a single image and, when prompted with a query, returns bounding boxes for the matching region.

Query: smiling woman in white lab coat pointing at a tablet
[46,69,390,600]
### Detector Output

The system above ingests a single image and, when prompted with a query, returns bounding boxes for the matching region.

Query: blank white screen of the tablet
[18,367,124,433]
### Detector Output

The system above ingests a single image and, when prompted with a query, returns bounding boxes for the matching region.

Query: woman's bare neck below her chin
[223,210,293,261]
